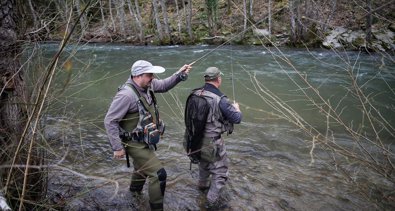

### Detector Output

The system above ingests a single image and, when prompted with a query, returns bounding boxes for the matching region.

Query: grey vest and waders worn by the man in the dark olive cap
[195,90,233,210]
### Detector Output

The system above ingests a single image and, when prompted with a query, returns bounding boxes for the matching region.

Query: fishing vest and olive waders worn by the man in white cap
[119,83,167,210]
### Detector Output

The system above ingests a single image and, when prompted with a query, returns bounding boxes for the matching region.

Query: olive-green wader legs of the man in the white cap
[127,142,167,210]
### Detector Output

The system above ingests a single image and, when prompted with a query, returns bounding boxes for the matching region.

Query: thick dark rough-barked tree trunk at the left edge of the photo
[0,0,26,152]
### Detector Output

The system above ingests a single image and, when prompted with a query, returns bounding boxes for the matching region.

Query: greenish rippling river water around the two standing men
[28,44,395,210]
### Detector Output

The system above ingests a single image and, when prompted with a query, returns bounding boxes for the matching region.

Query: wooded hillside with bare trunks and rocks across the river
[20,0,395,50]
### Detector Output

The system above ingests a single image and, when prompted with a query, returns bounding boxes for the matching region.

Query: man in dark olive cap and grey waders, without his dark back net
[188,67,242,209]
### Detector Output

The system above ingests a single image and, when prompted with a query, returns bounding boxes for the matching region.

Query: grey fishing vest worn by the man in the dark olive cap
[194,89,233,137]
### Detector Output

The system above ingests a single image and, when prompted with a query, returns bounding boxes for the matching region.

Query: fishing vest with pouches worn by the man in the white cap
[119,83,165,150]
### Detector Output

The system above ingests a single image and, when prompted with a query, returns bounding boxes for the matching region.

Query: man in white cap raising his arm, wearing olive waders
[104,60,192,210]
